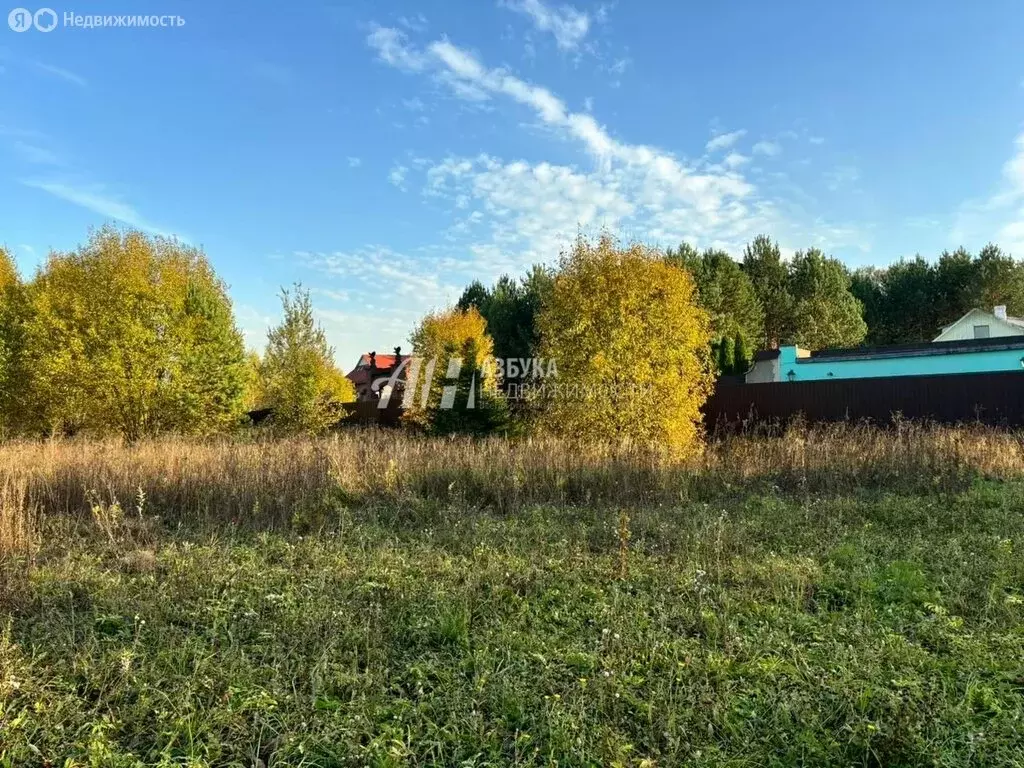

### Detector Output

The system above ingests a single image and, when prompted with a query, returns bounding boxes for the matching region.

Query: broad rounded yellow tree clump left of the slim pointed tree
[19,227,245,440]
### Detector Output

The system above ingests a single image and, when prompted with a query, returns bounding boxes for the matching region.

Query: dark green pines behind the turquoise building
[667,236,1024,360]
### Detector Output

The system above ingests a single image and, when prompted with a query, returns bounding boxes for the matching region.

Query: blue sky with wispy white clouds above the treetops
[0,0,1024,369]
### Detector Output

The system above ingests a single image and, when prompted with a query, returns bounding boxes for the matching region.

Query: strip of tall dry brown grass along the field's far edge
[0,424,1024,528]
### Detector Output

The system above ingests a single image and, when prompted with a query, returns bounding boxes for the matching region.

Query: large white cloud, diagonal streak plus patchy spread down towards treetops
[352,23,862,352]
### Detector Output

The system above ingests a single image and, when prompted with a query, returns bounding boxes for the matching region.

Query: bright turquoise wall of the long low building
[779,344,1024,381]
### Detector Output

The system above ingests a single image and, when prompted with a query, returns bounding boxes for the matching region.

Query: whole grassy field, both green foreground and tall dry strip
[0,426,1024,768]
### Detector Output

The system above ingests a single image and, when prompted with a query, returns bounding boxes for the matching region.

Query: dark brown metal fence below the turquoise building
[705,371,1024,429]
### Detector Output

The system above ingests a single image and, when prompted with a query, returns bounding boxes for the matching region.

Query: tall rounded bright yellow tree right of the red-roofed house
[538,236,713,456]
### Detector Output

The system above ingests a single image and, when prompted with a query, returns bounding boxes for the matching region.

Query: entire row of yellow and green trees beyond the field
[0,227,1024,450]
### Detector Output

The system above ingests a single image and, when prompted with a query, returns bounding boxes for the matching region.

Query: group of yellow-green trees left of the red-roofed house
[0,227,354,440]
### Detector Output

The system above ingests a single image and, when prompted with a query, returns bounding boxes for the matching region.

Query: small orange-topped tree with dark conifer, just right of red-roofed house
[402,306,504,433]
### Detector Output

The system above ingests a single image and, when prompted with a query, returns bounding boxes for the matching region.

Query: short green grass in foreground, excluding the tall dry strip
[0,482,1024,768]
